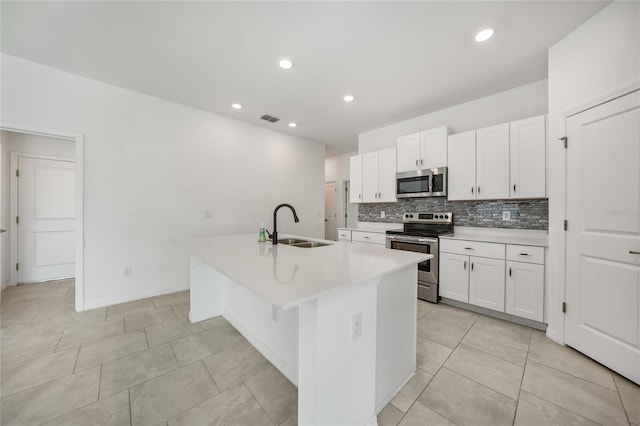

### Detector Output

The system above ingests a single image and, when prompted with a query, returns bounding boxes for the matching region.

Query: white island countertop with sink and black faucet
[174,234,433,309]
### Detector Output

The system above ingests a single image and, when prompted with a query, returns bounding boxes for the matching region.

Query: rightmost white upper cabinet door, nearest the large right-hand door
[509,115,547,198]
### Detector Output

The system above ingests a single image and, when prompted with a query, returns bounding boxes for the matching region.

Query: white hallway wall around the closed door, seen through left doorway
[0,131,75,289]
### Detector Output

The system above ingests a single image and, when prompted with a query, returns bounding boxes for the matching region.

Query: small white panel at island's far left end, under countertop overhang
[189,256,228,322]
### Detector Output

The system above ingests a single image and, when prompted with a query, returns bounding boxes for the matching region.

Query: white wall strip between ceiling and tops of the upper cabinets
[358,80,548,154]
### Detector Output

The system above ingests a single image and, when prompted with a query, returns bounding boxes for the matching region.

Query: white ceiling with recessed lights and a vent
[1,1,608,156]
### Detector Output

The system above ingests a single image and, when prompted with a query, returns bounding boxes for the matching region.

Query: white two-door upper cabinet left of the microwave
[349,148,396,203]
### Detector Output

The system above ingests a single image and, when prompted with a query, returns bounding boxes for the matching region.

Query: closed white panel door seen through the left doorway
[18,156,75,283]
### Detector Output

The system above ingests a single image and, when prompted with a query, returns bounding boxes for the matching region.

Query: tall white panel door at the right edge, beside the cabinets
[565,91,640,383]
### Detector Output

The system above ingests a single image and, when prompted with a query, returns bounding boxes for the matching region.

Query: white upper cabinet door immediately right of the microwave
[447,130,476,200]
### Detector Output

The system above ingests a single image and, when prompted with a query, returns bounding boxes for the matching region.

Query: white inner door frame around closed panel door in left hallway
[9,151,75,285]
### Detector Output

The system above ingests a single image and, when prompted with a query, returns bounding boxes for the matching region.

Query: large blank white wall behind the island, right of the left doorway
[2,55,325,309]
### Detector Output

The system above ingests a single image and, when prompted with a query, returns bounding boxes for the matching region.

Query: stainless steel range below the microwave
[386,212,453,303]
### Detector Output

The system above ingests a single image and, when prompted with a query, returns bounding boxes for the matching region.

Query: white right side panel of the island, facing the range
[376,265,418,413]
